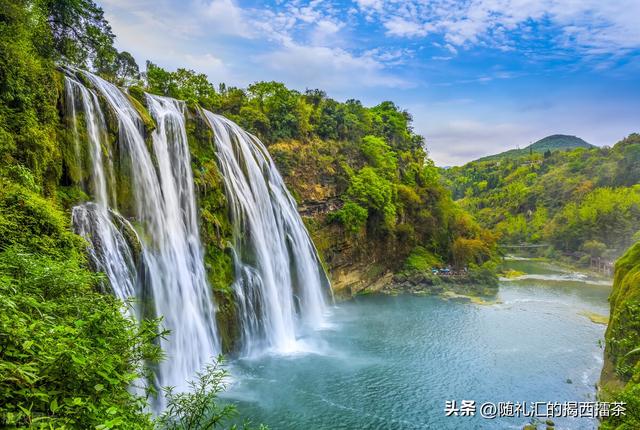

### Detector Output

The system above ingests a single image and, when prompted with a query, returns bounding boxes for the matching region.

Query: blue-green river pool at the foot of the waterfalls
[224,260,610,430]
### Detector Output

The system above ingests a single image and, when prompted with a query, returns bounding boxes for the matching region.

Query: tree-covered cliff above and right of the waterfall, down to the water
[141,63,495,296]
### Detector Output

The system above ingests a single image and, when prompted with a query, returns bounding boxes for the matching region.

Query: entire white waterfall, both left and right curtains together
[66,71,330,408]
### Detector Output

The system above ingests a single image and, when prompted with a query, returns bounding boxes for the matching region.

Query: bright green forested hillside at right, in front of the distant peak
[443,134,640,258]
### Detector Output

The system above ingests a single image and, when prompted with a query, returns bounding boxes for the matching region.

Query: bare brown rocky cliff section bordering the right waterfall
[269,141,410,297]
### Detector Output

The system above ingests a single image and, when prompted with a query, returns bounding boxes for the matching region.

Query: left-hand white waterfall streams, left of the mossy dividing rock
[66,72,220,407]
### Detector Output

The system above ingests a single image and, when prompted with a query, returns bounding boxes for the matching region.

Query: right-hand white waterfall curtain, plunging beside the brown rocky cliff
[203,110,329,355]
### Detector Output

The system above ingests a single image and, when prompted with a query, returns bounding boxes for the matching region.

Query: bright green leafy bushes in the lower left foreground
[0,247,160,428]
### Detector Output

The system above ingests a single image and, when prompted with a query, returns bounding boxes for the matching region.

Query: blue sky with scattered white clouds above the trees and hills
[98,0,640,165]
